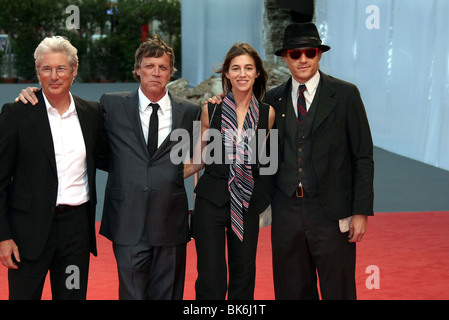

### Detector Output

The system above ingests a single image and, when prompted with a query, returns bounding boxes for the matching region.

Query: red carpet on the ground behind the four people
[0,212,449,300]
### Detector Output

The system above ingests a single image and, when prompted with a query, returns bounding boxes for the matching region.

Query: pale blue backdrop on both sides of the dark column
[182,0,449,170]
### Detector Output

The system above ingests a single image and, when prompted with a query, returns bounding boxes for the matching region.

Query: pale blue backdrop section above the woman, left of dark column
[181,0,265,86]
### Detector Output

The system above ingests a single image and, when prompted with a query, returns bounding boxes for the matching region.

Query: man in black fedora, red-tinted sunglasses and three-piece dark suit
[266,23,374,299]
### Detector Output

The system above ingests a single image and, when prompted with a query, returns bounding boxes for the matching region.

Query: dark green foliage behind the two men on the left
[0,0,181,81]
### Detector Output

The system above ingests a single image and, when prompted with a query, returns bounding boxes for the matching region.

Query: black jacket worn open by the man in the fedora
[266,71,374,220]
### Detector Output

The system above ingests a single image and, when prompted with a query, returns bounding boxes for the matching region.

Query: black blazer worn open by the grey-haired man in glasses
[0,91,102,260]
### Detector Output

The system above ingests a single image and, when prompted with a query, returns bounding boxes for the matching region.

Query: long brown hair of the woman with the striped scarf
[216,42,268,100]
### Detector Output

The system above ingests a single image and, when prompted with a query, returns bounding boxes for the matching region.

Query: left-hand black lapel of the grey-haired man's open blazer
[28,90,57,175]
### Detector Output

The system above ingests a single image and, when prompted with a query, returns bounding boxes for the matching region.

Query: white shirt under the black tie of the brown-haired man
[139,87,172,148]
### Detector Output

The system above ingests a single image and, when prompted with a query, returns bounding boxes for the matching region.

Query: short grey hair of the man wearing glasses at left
[34,36,78,71]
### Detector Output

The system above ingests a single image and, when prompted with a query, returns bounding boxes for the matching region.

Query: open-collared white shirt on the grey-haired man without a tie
[44,94,89,206]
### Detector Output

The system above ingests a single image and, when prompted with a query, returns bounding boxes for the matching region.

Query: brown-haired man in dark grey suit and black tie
[100,36,201,300]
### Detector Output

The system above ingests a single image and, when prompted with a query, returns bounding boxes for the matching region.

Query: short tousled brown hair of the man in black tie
[133,35,176,81]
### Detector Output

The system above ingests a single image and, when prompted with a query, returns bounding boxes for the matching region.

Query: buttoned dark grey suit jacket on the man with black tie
[100,90,201,246]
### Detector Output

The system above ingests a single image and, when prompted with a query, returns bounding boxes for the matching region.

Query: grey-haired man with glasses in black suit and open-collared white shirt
[0,37,102,299]
